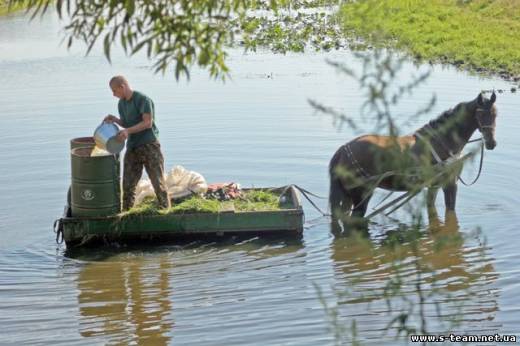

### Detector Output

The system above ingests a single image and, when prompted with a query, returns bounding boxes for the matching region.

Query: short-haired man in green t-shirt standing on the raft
[105,76,170,211]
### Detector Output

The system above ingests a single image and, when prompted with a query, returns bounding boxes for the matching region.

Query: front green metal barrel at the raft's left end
[70,148,121,217]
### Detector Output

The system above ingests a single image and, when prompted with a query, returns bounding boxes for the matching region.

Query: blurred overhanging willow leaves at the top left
[10,0,264,79]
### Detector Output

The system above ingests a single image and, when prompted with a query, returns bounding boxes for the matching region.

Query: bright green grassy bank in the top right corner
[339,0,520,78]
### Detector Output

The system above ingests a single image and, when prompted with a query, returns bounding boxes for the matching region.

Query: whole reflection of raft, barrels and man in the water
[72,237,303,345]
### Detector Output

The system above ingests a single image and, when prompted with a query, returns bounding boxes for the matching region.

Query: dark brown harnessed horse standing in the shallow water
[329,92,497,222]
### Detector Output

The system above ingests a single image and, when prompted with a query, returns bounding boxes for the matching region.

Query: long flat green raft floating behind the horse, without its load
[55,185,304,248]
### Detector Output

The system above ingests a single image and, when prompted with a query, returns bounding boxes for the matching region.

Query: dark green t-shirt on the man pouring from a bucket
[118,90,159,149]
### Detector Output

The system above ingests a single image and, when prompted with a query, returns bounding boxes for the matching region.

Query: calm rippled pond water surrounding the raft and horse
[0,11,520,345]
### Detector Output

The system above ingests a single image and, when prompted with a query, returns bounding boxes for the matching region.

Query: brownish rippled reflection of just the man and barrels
[78,254,173,345]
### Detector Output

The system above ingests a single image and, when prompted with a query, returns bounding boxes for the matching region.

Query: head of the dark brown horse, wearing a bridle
[475,91,497,150]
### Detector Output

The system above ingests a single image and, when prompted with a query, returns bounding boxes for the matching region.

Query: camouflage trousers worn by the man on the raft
[123,142,170,210]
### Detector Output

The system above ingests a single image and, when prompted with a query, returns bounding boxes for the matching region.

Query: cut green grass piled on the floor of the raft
[122,190,280,216]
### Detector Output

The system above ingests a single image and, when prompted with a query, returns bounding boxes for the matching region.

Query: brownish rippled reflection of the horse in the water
[331,211,498,335]
